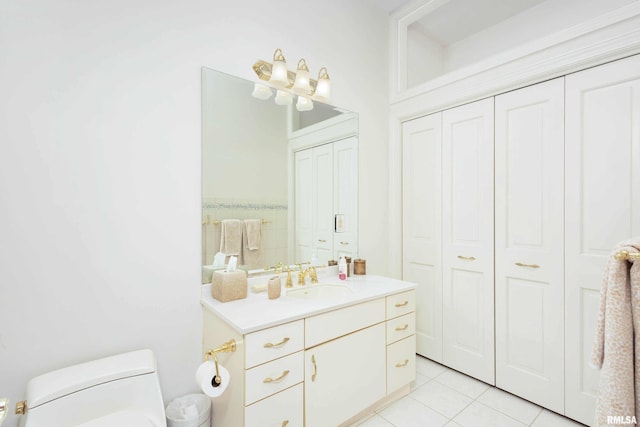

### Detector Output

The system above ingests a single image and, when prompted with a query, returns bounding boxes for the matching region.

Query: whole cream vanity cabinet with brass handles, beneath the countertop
[203,283,415,427]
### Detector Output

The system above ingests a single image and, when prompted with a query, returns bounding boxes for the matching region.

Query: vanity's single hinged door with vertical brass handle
[304,323,386,427]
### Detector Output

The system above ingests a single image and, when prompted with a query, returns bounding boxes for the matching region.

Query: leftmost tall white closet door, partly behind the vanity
[402,113,442,363]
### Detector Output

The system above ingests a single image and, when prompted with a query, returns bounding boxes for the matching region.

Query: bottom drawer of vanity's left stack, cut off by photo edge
[245,384,304,427]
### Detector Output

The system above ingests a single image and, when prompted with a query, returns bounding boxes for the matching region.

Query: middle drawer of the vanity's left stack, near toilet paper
[244,351,304,405]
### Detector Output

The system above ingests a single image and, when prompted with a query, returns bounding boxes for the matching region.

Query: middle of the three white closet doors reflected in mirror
[312,144,333,263]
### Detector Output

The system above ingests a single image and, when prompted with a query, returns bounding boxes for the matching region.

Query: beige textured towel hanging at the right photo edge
[591,239,640,426]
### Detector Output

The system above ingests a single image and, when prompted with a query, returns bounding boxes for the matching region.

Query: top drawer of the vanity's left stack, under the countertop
[244,320,304,369]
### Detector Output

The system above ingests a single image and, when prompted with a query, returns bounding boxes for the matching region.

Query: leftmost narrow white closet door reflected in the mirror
[291,150,313,261]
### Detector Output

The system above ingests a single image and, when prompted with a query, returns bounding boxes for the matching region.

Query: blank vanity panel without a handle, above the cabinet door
[304,298,385,348]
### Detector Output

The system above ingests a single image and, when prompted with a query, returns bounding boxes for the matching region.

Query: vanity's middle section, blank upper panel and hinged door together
[304,298,386,427]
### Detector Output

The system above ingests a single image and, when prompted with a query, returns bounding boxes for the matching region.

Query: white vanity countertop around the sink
[200,267,416,334]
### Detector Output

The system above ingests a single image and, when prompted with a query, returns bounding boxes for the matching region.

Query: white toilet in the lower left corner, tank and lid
[20,350,167,427]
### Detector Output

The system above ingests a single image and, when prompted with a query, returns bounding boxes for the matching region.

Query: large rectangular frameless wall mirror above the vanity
[201,68,358,283]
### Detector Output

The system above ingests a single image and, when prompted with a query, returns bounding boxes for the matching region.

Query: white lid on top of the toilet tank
[27,350,156,409]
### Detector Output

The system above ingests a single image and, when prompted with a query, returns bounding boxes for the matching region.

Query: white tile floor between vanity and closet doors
[358,356,584,427]
